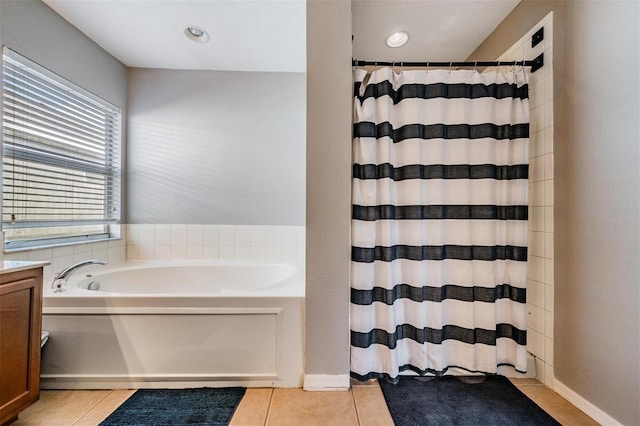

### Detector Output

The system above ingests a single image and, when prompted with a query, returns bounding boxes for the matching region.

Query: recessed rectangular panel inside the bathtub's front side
[42,313,277,378]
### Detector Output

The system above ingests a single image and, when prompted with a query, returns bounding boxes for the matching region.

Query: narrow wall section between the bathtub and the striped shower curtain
[305,0,352,375]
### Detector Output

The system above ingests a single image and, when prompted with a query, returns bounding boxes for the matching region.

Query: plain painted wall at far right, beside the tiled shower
[471,0,640,425]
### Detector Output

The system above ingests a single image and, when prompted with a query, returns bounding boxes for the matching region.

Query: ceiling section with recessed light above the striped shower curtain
[351,0,520,62]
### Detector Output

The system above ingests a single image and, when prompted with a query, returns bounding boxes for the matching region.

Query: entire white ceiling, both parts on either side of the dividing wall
[43,0,520,72]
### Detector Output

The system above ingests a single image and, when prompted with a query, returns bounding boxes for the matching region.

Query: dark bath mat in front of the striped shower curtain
[380,376,560,426]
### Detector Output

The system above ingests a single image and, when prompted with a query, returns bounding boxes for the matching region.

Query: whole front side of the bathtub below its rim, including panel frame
[42,298,303,389]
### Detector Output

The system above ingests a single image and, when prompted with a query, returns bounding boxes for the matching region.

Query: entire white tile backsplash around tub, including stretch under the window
[2,224,305,283]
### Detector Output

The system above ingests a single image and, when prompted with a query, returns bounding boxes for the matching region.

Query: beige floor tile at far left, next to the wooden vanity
[11,390,111,426]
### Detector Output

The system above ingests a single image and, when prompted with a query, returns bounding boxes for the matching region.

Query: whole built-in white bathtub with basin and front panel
[41,261,304,389]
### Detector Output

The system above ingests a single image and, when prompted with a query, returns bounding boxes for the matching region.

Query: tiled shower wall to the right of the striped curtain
[499,13,554,389]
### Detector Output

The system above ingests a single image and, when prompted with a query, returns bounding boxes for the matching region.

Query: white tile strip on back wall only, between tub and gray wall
[126,224,305,266]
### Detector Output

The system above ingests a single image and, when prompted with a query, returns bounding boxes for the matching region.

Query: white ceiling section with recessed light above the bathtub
[43,0,306,72]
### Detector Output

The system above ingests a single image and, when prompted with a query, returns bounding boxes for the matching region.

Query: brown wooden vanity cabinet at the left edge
[0,267,42,425]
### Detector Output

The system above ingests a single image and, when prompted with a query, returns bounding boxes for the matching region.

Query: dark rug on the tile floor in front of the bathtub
[100,388,246,426]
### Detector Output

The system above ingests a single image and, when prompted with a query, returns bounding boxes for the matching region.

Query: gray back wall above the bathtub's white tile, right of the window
[126,68,305,225]
